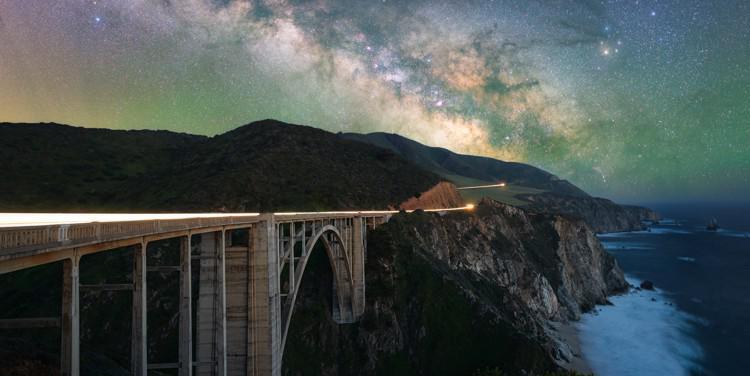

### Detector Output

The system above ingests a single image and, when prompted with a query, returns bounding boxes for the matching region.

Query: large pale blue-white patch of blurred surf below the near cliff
[578,276,703,376]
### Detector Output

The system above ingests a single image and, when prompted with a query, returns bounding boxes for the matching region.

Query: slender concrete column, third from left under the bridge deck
[178,235,193,376]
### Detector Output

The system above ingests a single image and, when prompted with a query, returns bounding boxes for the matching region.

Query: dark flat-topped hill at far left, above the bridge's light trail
[0,124,205,211]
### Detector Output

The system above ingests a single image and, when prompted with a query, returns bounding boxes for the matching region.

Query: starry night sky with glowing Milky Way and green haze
[0,0,750,202]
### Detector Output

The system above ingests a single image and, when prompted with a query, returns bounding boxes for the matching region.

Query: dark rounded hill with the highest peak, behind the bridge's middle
[136,121,440,211]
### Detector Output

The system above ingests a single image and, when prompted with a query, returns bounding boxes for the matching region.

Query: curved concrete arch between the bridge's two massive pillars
[280,224,357,357]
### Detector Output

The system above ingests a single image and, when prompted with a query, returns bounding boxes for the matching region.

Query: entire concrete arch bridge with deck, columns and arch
[0,207,469,376]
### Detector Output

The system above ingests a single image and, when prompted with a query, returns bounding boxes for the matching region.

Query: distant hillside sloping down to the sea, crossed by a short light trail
[339,133,659,232]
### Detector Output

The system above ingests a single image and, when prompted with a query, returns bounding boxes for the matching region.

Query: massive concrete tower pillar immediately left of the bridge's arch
[247,216,281,376]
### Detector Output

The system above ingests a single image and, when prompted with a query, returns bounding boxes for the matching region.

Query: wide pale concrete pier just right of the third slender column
[195,232,226,376]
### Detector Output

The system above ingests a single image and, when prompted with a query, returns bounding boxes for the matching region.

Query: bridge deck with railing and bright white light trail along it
[0,205,472,273]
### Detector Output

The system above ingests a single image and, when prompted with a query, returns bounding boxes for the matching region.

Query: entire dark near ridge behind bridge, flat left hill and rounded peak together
[0,120,441,211]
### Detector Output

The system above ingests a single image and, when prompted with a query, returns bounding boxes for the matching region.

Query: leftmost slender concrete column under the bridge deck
[60,253,80,376]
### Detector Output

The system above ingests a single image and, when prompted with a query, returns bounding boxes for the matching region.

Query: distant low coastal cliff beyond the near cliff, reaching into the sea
[519,193,659,233]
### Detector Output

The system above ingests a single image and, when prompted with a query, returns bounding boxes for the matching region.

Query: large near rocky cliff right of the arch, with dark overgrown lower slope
[284,201,627,375]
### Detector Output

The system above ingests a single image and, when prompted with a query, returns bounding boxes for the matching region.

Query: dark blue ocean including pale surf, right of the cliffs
[578,204,750,376]
